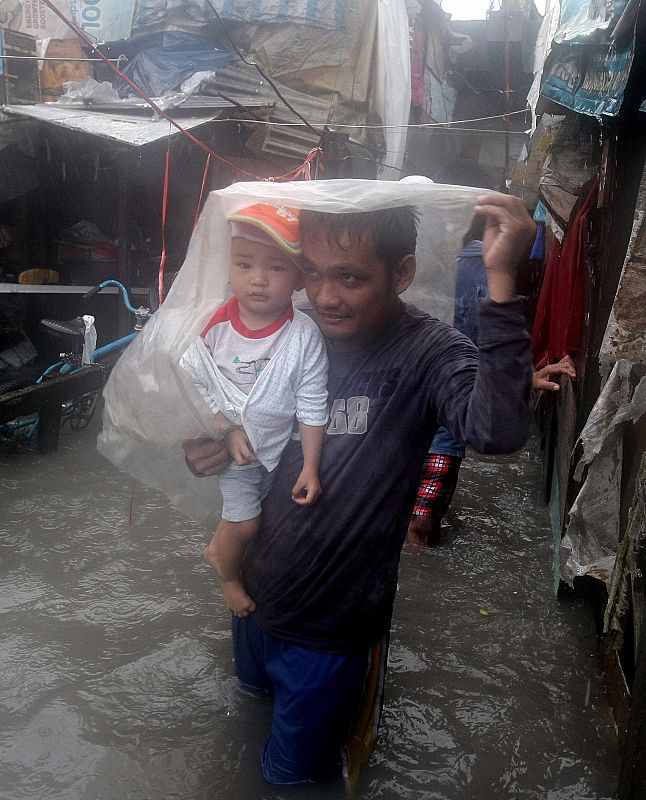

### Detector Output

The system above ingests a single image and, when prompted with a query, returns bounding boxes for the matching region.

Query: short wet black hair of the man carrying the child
[301,206,419,273]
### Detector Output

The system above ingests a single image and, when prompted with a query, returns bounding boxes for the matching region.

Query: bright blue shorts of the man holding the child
[233,614,369,784]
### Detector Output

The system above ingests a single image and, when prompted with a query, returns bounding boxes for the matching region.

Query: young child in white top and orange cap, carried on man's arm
[180,203,327,617]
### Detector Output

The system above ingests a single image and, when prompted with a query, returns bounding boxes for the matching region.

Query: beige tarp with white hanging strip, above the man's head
[218,0,411,178]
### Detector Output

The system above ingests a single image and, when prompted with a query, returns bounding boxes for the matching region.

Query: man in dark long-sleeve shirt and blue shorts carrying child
[184,194,534,784]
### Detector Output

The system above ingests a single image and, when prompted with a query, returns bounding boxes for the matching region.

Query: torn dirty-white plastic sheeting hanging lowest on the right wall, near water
[560,361,646,584]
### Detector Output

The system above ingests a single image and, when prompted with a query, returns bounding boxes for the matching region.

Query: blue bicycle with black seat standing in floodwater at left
[0,280,154,452]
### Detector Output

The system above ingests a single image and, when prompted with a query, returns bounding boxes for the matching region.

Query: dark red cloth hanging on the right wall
[532,183,598,369]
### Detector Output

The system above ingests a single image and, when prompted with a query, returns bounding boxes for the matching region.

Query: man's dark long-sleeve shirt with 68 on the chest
[243,299,532,652]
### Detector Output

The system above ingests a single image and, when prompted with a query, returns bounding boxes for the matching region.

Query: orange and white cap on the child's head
[227,203,303,258]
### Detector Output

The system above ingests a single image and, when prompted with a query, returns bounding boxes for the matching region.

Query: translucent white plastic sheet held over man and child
[99,180,482,523]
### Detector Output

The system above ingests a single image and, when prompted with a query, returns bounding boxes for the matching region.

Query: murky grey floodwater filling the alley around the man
[0,418,618,800]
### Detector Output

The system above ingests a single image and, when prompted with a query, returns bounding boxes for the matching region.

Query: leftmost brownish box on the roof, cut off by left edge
[0,28,40,105]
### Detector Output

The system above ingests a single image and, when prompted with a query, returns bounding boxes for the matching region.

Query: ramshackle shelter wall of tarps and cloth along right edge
[512,0,646,800]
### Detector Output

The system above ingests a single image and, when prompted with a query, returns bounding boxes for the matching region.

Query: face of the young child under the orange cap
[229,236,302,325]
